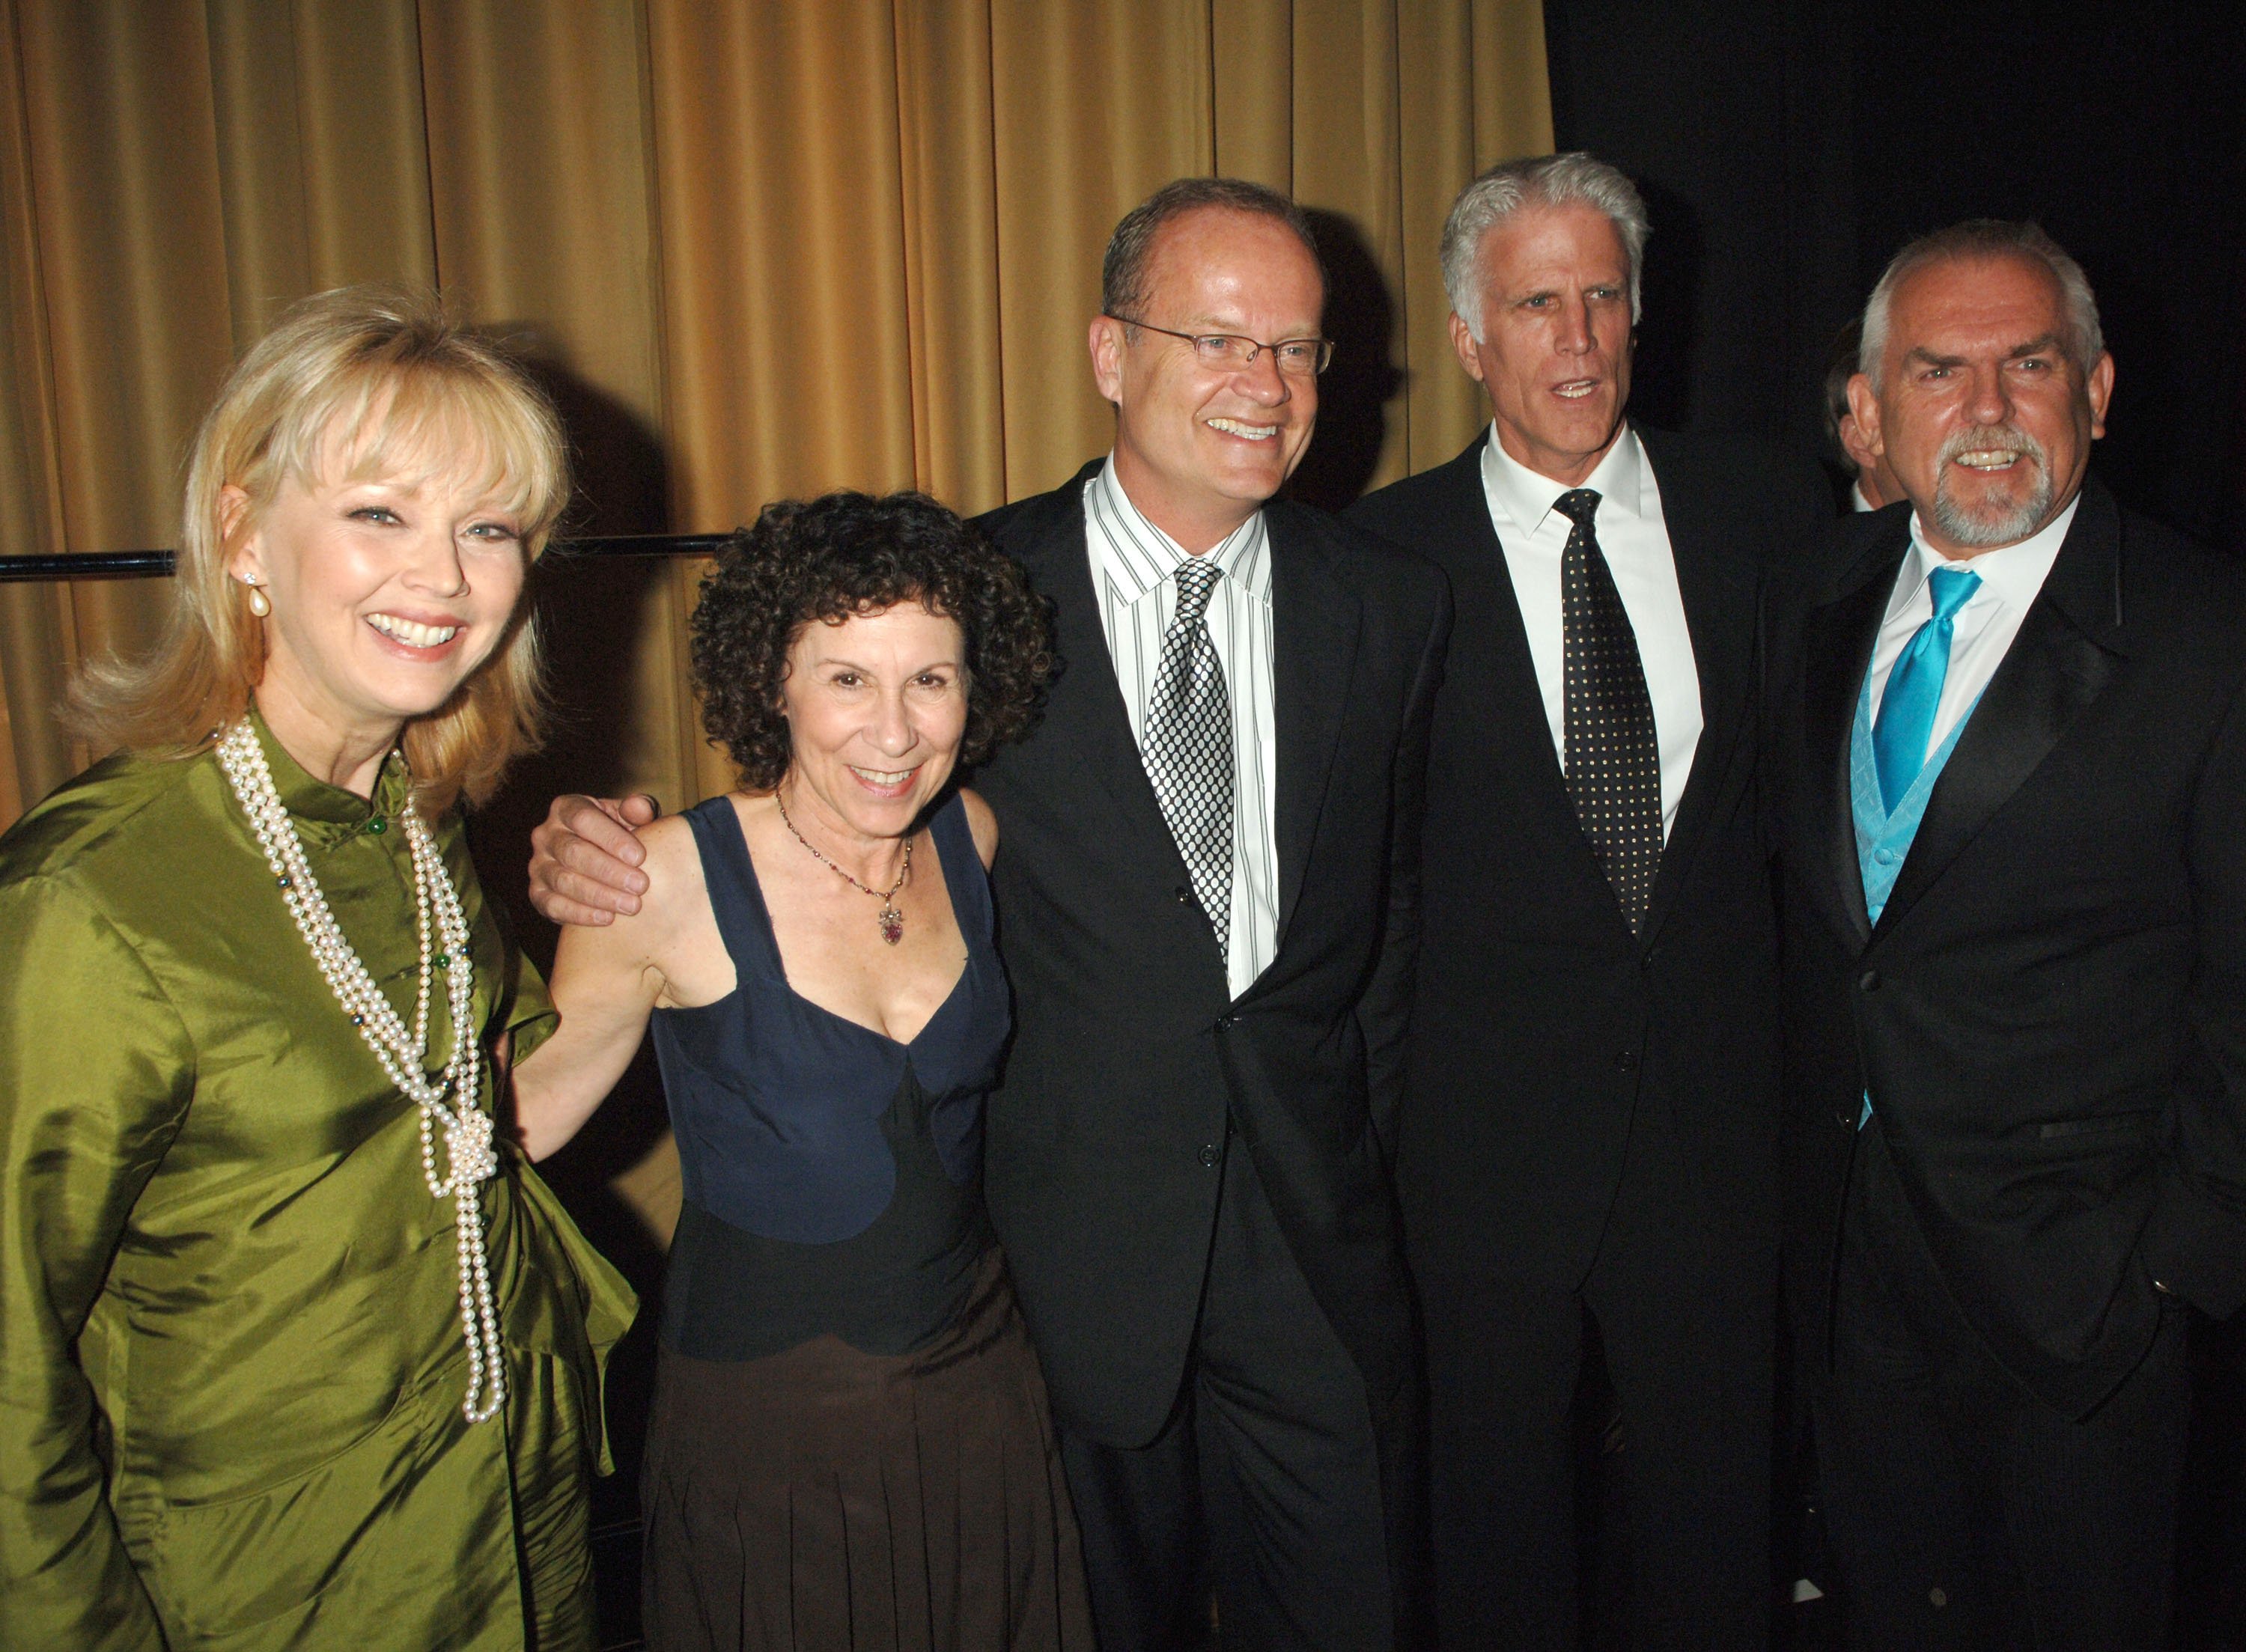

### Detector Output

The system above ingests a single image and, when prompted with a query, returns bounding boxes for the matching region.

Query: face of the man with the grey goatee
[1848,254,2113,559]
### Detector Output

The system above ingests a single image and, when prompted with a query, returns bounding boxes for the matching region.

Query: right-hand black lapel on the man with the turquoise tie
[1873,487,2122,938]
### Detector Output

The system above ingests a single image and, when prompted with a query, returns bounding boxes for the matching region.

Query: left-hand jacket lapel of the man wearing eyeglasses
[1017,478,1186,882]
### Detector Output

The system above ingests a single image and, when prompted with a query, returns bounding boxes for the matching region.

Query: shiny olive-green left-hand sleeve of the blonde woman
[0,877,193,1652]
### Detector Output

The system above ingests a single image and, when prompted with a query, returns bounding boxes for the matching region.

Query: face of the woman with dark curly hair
[779,602,968,841]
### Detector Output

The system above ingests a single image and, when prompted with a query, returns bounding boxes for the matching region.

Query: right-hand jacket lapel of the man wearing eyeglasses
[1264,505,1359,942]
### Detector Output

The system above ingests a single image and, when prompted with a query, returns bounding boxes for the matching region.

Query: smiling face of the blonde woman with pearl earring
[220,419,528,772]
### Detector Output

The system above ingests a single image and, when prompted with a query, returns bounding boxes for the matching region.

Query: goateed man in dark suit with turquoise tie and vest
[1768,222,2246,1652]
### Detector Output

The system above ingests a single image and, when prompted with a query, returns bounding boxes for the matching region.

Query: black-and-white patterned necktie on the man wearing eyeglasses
[1145,557,1233,951]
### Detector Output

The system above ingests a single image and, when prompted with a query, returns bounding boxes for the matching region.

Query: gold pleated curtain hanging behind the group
[0,0,1552,1225]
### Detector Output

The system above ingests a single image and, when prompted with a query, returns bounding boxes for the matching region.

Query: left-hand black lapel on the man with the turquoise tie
[1801,536,1909,947]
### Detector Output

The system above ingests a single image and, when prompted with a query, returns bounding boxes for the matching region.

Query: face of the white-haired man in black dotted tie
[1451,204,1631,487]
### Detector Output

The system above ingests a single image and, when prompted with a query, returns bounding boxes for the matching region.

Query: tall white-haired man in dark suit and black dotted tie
[1352,155,1830,1652]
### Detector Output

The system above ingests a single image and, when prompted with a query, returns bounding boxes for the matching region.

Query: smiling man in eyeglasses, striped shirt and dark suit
[532,180,1449,1652]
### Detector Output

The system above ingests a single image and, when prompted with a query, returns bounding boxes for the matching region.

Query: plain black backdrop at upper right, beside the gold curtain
[1545,0,2246,552]
